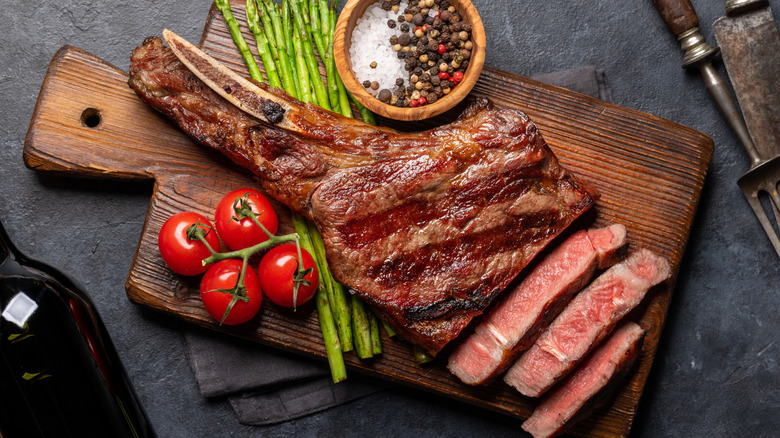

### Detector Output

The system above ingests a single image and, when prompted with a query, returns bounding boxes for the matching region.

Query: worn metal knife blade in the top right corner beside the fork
[713,0,780,159]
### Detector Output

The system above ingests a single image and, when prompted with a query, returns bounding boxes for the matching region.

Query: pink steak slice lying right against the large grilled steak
[448,224,626,385]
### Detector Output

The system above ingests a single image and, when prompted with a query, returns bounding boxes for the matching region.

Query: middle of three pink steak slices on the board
[504,249,671,397]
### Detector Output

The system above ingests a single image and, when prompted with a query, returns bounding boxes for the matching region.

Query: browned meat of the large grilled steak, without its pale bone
[129,37,598,355]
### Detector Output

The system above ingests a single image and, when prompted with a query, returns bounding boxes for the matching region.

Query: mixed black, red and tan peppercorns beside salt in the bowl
[363,0,474,108]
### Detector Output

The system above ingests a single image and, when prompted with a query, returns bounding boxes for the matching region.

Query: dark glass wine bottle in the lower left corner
[0,219,156,438]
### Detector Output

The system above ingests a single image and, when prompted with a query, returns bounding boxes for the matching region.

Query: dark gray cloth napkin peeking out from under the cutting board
[185,66,612,426]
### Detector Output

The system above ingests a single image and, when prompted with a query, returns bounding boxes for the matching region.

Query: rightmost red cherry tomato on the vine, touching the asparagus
[257,243,320,307]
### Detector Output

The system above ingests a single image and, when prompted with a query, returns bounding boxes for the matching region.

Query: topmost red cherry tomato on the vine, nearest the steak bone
[214,188,279,251]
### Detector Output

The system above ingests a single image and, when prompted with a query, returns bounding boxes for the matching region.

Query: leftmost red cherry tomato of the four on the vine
[157,211,219,275]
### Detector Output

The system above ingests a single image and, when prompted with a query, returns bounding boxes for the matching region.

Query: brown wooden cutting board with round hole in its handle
[24,2,713,437]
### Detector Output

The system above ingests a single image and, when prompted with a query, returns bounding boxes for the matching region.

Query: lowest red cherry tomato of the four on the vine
[200,259,263,325]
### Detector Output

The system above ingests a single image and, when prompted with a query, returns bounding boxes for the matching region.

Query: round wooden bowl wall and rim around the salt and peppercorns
[333,0,485,120]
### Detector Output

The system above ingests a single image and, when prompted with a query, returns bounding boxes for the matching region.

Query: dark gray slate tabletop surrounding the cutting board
[0,0,780,437]
